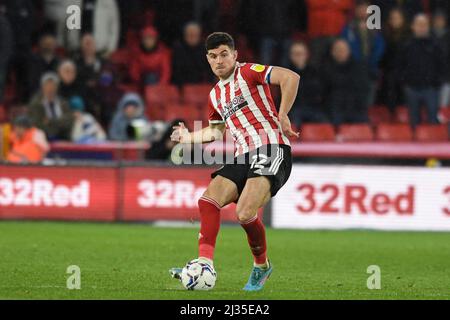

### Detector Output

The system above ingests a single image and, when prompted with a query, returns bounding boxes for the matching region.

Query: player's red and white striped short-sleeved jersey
[208,63,290,156]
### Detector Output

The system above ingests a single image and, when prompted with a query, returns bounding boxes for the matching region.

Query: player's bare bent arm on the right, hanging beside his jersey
[270,67,300,138]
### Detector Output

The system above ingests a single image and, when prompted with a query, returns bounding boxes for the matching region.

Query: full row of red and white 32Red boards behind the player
[0,163,450,231]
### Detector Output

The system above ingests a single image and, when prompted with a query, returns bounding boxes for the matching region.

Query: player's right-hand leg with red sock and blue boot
[236,176,272,291]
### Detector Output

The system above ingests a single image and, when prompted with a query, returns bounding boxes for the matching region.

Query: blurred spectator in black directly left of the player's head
[172,22,212,86]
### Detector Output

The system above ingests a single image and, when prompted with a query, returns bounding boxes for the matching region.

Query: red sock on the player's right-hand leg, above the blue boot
[241,215,267,264]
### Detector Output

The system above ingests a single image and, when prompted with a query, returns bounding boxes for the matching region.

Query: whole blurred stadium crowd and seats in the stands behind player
[0,0,450,162]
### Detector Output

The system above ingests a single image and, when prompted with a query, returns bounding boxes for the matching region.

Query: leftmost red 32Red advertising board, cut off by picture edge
[0,166,118,221]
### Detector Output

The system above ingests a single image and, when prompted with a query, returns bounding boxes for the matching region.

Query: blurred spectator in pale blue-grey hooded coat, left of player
[109,93,149,141]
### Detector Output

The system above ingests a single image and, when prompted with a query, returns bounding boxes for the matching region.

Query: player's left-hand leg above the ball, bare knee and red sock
[198,176,238,263]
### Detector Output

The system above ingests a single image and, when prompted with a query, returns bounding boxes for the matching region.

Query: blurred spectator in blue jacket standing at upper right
[342,0,385,106]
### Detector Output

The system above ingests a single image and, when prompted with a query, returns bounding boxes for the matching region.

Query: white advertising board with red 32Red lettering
[272,165,450,231]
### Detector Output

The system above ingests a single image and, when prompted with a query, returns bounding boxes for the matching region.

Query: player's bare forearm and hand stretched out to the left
[170,122,225,144]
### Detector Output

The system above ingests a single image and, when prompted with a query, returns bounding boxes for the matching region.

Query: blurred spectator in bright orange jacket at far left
[6,116,50,163]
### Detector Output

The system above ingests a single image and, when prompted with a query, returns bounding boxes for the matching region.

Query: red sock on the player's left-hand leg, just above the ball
[198,196,220,260]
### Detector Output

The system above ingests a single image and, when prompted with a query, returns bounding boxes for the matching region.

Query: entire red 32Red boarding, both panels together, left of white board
[0,165,255,222]
